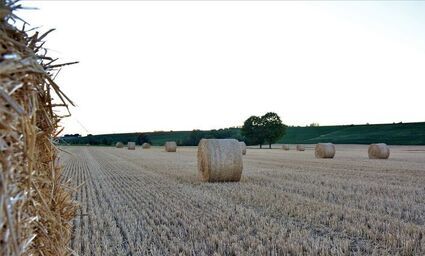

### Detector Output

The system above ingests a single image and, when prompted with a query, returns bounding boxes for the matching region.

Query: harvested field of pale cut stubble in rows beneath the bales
[61,145,425,255]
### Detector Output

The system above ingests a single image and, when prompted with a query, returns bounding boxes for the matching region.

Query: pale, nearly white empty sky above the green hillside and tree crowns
[18,1,425,134]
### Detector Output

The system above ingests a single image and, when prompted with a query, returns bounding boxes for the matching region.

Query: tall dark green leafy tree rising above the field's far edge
[241,112,286,148]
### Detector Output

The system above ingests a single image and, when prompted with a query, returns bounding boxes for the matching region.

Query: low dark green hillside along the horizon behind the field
[61,122,425,146]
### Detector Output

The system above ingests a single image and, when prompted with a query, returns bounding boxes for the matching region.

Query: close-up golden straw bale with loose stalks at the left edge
[0,0,77,256]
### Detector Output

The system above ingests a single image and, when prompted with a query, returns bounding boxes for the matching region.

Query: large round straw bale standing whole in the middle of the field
[198,139,243,182]
